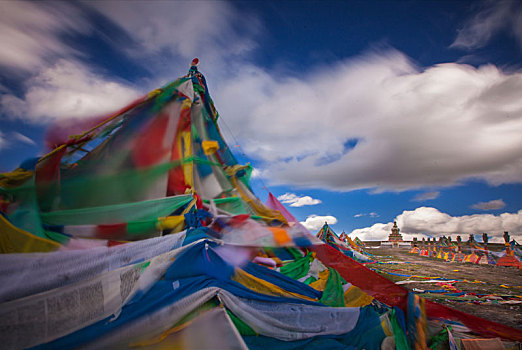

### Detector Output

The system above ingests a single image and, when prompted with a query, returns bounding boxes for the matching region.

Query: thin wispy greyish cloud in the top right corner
[450,1,522,50]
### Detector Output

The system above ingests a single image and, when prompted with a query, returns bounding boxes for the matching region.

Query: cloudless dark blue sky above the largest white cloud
[235,1,522,70]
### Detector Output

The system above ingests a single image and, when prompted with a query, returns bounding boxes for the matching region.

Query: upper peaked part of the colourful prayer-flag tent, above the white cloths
[0,62,314,252]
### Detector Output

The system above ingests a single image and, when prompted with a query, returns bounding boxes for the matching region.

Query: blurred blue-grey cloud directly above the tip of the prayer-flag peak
[85,1,263,81]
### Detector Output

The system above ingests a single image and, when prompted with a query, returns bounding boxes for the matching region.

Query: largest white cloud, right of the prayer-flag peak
[214,50,522,191]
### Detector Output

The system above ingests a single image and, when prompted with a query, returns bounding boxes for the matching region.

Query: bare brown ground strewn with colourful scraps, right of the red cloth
[366,249,522,330]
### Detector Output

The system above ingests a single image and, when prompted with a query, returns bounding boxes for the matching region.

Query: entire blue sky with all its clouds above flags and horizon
[0,1,522,242]
